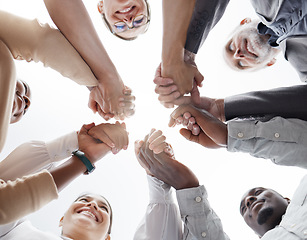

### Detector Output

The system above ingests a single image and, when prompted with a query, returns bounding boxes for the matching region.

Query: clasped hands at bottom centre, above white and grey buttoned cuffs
[135,130,199,190]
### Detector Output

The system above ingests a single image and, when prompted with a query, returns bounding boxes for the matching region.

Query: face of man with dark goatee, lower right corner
[240,187,289,237]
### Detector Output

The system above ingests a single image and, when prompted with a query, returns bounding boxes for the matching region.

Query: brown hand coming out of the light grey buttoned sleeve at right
[169,105,228,148]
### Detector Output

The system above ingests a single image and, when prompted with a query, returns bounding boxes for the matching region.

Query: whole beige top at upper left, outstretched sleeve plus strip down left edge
[0,11,98,151]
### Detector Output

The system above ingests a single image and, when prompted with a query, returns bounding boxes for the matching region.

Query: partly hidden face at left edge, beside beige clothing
[10,80,31,123]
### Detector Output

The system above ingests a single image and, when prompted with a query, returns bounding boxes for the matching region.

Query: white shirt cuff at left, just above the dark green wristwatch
[46,132,79,162]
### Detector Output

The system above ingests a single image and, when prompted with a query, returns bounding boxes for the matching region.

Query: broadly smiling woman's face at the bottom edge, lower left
[60,194,111,240]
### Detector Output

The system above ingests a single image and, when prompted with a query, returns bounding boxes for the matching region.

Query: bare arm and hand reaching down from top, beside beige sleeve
[45,0,132,119]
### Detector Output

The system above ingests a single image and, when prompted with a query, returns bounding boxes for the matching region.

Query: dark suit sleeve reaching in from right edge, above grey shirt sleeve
[225,85,307,121]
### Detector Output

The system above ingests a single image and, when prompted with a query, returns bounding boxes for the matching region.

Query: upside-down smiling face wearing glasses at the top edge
[98,0,150,38]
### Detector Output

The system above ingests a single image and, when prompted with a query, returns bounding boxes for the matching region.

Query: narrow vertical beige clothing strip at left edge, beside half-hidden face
[0,40,16,152]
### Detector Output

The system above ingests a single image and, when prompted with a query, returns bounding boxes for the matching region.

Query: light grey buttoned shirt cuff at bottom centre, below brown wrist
[176,185,210,215]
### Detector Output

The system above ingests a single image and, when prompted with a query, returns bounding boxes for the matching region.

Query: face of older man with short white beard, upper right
[224,18,279,70]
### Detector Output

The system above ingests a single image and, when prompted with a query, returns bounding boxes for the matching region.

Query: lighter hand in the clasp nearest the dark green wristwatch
[88,122,129,154]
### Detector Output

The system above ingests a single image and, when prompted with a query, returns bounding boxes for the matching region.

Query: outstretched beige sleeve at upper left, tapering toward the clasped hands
[0,11,97,86]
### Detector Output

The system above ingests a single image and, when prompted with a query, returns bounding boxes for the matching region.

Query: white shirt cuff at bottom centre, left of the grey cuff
[147,175,174,204]
